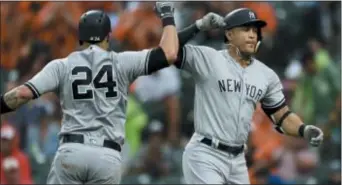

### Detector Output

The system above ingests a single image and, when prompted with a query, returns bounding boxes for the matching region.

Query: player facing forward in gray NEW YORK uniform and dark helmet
[175,8,323,184]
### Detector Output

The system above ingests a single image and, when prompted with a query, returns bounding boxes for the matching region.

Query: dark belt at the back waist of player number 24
[62,134,121,152]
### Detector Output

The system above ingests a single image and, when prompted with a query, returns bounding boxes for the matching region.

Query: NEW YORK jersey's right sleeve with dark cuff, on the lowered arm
[261,70,286,115]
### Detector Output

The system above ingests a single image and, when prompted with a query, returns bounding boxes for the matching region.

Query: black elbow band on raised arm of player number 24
[147,47,169,74]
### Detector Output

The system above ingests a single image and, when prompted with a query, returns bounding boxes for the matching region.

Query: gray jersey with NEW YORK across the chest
[178,45,285,145]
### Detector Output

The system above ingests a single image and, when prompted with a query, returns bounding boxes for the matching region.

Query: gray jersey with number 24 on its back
[26,45,150,144]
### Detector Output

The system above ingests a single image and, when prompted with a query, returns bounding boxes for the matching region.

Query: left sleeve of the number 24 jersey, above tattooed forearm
[24,60,66,98]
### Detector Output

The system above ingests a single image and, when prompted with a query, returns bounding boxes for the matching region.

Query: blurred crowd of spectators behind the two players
[0,1,341,184]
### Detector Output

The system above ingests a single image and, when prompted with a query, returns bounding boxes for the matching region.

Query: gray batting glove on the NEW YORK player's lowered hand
[304,125,323,147]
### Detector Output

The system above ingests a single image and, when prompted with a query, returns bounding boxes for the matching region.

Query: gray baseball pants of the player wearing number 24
[47,143,121,184]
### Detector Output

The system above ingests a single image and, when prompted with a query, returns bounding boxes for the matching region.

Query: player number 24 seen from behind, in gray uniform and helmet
[0,2,179,184]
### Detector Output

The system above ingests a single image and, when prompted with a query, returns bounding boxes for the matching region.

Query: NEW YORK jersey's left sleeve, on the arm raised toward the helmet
[175,45,215,76]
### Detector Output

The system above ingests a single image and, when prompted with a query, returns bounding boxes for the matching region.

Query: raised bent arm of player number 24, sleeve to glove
[118,1,179,82]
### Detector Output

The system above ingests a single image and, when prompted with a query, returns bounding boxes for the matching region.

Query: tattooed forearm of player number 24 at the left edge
[0,85,33,114]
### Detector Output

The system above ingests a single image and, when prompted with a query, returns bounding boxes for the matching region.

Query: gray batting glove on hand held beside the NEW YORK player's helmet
[196,12,226,31]
